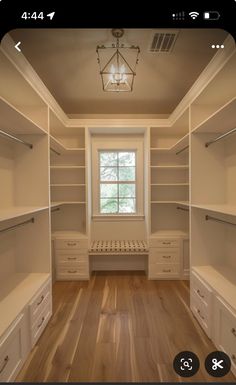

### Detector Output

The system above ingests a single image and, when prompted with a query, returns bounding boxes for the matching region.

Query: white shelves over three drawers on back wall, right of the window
[148,109,189,279]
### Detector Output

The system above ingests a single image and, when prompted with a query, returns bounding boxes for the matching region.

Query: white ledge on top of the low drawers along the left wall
[0,273,50,336]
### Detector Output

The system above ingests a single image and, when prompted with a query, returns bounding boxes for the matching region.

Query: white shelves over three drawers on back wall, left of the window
[49,110,89,280]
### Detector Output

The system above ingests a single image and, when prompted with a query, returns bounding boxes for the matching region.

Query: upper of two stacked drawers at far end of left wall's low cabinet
[29,281,51,325]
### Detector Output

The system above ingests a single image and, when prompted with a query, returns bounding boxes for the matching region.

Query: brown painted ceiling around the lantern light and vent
[10,29,227,117]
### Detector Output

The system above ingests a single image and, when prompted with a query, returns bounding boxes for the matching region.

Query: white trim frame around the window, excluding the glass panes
[92,136,144,220]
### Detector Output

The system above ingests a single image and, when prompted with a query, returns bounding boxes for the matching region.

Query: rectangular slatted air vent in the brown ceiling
[149,32,178,53]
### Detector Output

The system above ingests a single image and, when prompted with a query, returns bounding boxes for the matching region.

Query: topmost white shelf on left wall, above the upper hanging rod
[0,98,46,135]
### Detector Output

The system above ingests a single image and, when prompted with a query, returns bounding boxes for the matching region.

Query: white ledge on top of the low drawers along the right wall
[193,266,236,310]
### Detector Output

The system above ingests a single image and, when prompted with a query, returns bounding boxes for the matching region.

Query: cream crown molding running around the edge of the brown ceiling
[0,34,236,127]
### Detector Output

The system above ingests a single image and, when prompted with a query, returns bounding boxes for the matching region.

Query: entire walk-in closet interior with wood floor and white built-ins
[0,29,236,382]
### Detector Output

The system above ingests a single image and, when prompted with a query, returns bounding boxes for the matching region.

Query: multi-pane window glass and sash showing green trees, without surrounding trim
[99,150,137,214]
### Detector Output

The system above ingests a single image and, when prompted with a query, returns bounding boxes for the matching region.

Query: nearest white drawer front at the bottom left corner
[0,314,27,382]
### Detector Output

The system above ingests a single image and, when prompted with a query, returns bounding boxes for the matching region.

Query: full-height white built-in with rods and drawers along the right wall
[190,53,236,374]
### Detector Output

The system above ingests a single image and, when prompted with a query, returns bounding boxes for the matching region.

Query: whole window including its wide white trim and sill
[92,133,145,218]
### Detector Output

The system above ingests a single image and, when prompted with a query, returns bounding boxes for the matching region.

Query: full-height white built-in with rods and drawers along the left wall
[0,51,52,382]
